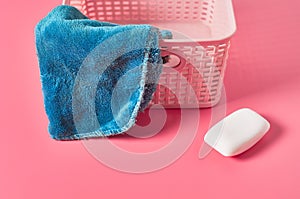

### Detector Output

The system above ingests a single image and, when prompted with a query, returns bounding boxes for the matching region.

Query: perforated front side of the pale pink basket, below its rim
[151,40,230,108]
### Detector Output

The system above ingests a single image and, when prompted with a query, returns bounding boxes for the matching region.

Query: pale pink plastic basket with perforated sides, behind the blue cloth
[63,0,236,108]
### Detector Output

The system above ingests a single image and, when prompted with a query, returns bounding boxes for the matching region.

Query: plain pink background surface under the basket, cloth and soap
[0,0,300,199]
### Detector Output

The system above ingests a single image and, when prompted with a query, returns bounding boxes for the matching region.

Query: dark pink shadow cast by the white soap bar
[233,115,283,161]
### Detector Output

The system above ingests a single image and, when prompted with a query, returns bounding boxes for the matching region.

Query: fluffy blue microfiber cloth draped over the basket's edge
[35,6,170,140]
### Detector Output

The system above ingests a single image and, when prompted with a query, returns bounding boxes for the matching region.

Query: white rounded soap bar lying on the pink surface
[204,108,270,156]
